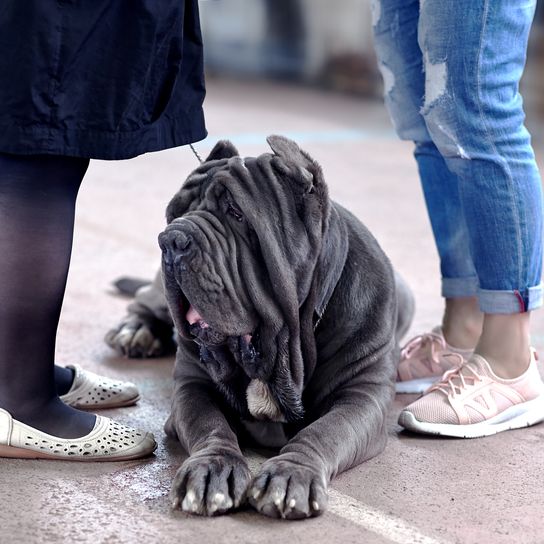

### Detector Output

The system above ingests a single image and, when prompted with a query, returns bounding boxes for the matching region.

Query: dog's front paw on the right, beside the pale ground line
[248,455,327,519]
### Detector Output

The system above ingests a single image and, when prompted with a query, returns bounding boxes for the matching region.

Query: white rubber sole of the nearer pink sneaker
[399,395,544,438]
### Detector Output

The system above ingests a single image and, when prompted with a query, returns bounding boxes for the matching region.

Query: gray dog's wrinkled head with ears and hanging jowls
[159,136,342,420]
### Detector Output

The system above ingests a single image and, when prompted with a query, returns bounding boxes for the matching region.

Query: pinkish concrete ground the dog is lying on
[0,80,544,544]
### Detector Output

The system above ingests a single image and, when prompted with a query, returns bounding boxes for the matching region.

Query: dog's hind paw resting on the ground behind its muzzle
[105,314,174,359]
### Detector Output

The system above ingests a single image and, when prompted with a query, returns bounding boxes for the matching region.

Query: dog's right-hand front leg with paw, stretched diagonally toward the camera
[248,370,393,519]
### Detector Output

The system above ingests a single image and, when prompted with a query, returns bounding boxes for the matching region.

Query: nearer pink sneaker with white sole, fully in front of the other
[399,350,544,438]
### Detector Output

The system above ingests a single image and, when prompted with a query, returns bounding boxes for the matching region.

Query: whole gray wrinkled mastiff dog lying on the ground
[108,136,413,519]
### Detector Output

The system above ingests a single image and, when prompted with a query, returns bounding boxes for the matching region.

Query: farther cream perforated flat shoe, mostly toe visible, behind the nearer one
[60,365,140,410]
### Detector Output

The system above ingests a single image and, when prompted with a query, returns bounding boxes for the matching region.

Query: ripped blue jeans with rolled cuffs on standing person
[372,0,542,313]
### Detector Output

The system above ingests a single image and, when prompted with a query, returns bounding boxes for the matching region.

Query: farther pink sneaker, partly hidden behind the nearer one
[395,327,472,393]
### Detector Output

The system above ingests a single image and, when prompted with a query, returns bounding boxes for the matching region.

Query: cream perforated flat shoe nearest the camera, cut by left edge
[0,409,157,461]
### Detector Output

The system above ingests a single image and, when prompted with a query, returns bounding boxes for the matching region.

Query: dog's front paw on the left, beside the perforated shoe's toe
[170,454,251,516]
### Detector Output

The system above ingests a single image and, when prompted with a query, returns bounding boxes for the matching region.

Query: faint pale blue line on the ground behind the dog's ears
[198,128,395,148]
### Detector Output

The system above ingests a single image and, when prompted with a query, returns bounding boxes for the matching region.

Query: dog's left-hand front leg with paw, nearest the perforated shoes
[165,372,251,516]
